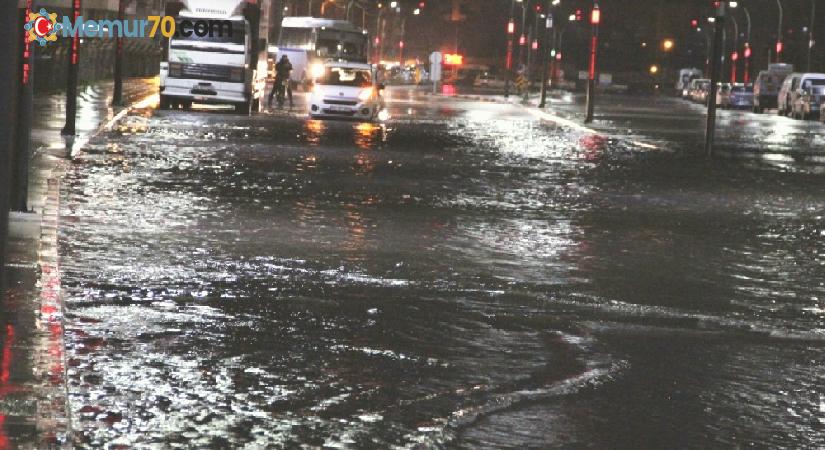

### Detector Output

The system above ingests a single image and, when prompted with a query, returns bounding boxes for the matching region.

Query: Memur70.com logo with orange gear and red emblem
[24,9,232,46]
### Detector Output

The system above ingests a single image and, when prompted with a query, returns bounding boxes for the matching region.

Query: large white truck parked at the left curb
[160,0,270,114]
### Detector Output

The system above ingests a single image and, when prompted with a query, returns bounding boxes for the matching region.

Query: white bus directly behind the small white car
[270,17,369,84]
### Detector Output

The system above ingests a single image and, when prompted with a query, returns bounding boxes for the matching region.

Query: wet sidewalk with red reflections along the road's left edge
[0,79,157,450]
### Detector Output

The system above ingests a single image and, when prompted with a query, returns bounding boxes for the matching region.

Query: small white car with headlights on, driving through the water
[309,62,384,121]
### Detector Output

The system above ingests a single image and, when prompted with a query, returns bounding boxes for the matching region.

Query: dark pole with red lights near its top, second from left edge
[11,0,34,212]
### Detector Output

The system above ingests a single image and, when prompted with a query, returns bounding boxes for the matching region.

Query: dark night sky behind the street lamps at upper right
[380,0,825,76]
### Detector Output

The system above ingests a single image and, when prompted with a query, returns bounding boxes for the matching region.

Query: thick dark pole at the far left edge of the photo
[0,1,23,292]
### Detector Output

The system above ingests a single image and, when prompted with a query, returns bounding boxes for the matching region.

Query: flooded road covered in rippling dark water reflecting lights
[61,90,825,448]
